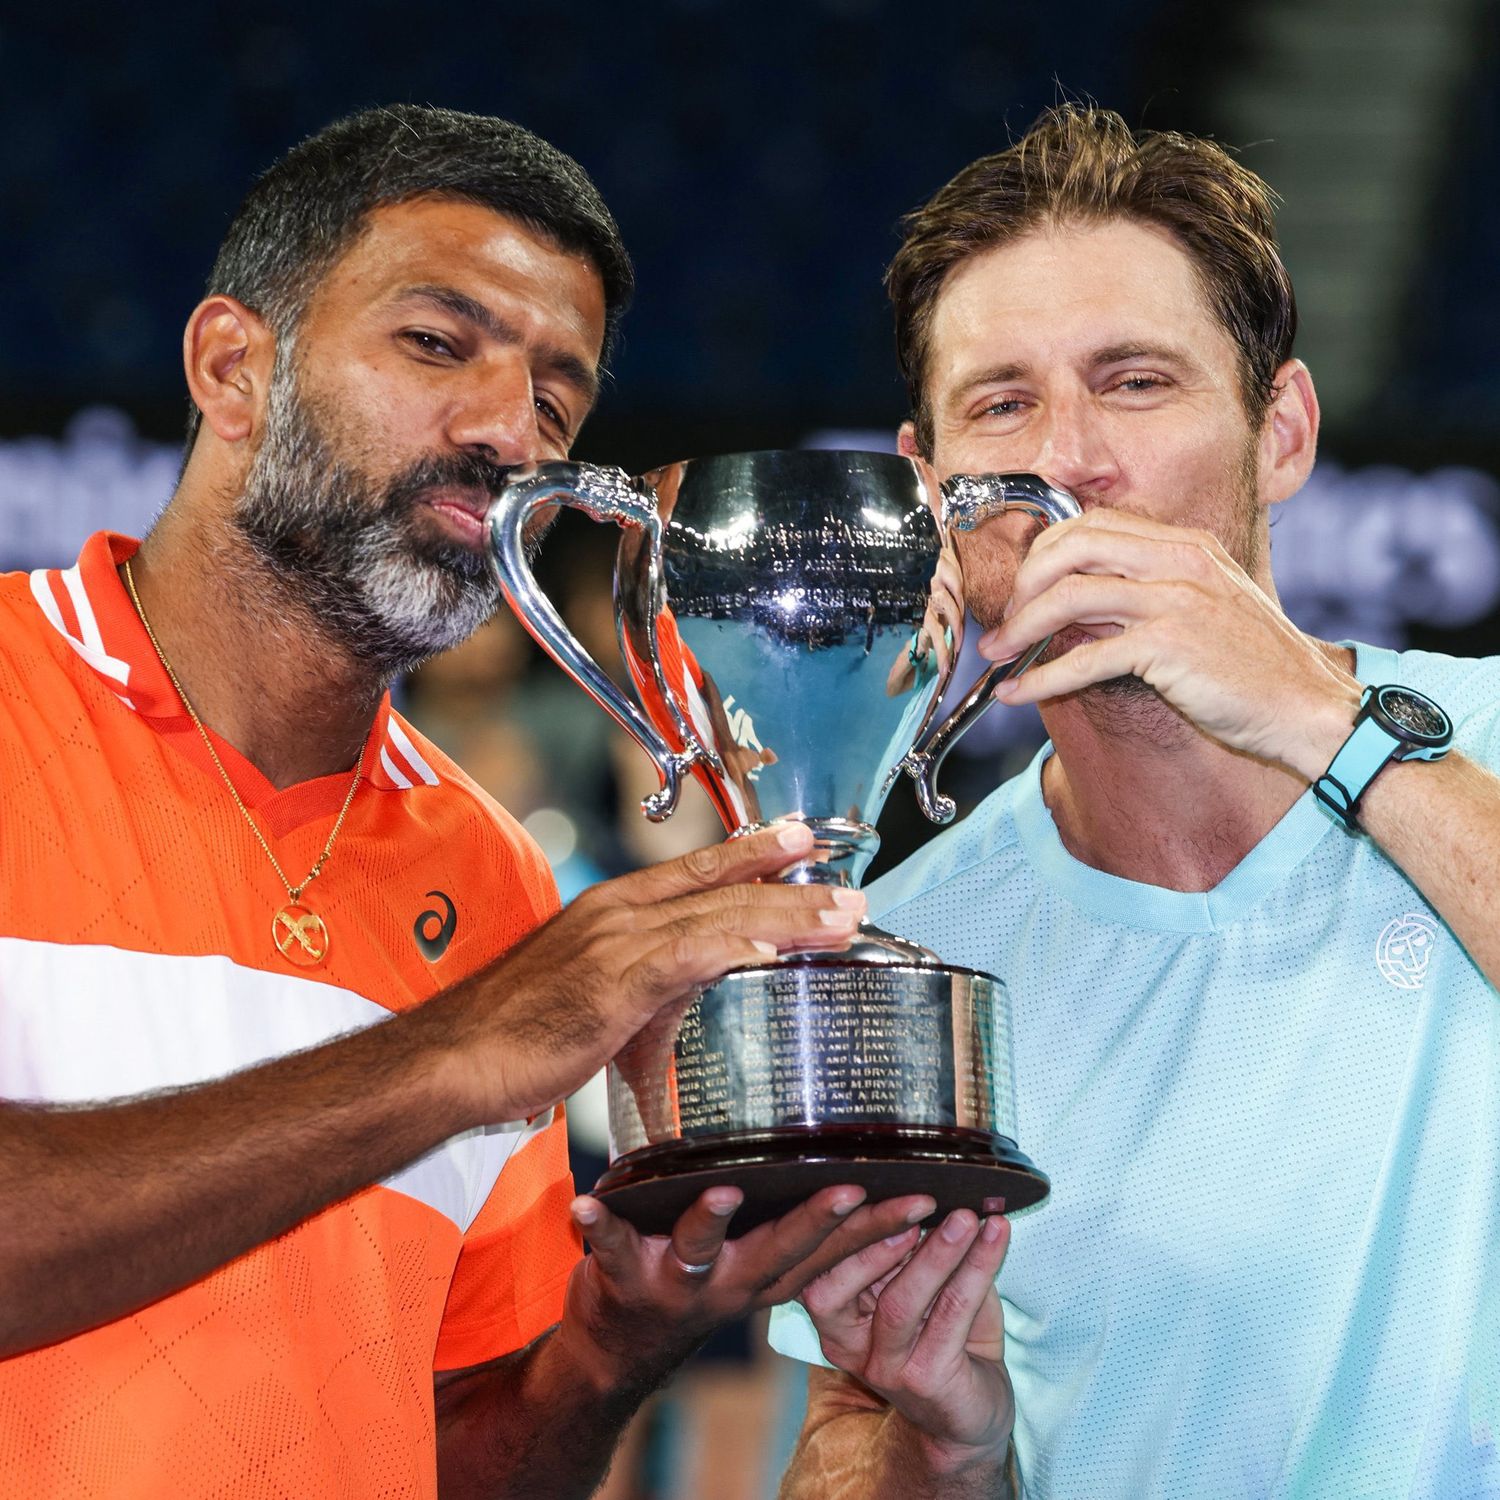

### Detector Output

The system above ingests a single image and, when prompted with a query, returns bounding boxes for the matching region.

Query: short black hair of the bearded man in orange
[189,104,635,441]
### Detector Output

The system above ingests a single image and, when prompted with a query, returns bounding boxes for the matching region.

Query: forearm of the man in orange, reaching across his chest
[0,990,473,1356]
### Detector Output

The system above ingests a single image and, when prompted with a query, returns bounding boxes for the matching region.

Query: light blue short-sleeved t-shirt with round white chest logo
[771,647,1500,1500]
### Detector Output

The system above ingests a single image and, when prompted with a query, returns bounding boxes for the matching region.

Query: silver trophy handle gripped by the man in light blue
[900,474,1082,824]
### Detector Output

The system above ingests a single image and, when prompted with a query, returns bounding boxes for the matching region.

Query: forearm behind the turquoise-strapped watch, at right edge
[1359,752,1500,987]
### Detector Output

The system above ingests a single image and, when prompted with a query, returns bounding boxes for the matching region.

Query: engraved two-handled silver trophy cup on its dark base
[489,450,1079,1233]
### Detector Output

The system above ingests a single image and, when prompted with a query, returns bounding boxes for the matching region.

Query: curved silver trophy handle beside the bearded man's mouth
[486,464,710,822]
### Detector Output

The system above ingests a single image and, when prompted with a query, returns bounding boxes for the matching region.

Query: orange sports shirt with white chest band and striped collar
[0,533,581,1500]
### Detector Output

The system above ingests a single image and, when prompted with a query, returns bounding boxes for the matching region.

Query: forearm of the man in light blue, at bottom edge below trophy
[780,1407,1022,1500]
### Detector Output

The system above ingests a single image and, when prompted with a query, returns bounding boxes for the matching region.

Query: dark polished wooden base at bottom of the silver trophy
[594,1125,1052,1238]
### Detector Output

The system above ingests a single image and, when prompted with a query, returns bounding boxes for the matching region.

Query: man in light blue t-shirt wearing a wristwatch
[773,99,1500,1500]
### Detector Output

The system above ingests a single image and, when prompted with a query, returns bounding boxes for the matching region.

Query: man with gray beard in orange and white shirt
[0,107,932,1500]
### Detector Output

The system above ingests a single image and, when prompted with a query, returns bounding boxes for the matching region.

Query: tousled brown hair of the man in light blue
[885,104,1298,453]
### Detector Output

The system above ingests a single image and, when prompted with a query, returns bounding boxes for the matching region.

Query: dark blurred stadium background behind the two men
[0,0,1500,1500]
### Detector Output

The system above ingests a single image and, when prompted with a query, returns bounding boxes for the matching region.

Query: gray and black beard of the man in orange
[234,350,506,680]
